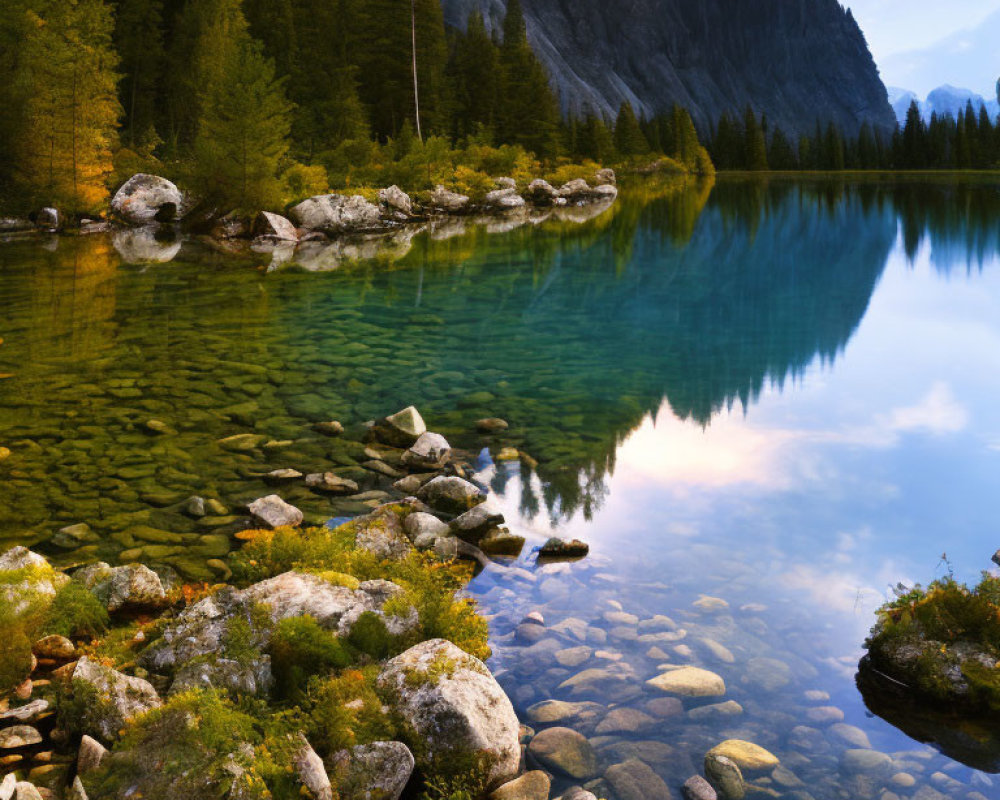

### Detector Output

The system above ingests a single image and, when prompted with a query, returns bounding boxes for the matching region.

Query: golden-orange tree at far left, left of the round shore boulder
[14,0,121,211]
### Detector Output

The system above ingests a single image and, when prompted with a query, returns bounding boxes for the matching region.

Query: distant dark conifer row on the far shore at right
[708,102,1000,171]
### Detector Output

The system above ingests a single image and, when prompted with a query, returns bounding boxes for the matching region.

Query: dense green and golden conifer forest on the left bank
[0,0,710,216]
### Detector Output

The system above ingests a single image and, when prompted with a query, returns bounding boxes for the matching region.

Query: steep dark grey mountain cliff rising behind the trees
[444,0,895,133]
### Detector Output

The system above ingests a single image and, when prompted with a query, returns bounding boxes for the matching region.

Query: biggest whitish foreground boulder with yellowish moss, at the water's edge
[378,639,521,788]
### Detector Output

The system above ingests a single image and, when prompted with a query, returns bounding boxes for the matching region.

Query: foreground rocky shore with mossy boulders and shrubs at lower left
[0,408,586,800]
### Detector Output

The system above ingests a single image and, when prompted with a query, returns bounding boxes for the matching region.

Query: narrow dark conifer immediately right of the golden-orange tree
[114,0,164,148]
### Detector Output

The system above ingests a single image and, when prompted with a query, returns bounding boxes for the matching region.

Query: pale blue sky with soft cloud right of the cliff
[842,0,1000,96]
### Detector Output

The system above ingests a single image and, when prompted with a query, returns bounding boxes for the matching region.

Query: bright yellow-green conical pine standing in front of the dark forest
[192,12,292,210]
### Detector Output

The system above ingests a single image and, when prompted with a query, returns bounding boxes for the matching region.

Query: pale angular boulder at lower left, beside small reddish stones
[72,656,162,741]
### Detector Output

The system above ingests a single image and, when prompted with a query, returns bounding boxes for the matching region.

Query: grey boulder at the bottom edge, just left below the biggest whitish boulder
[330,742,415,800]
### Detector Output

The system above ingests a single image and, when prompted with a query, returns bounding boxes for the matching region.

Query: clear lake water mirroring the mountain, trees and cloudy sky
[0,181,1000,800]
